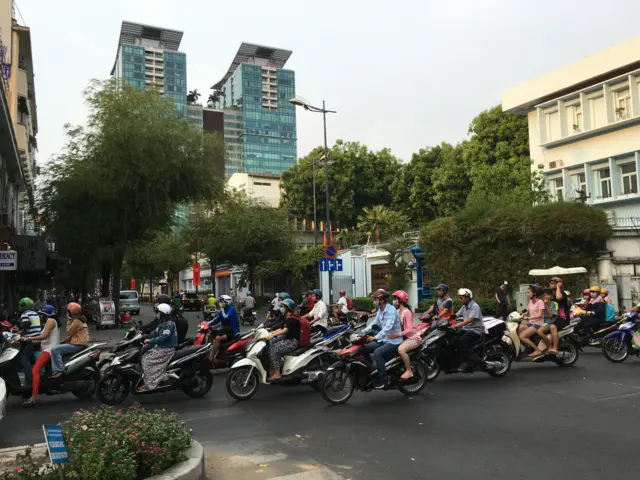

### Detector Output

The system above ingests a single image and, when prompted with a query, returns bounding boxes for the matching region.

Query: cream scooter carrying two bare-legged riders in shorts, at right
[504,312,582,367]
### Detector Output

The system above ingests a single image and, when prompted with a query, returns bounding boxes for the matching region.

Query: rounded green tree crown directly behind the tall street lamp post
[281,140,400,228]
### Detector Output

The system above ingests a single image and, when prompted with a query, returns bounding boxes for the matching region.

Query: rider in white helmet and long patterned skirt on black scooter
[138,303,178,392]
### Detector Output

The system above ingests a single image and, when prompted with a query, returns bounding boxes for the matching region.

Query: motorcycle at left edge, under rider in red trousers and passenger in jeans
[0,334,105,398]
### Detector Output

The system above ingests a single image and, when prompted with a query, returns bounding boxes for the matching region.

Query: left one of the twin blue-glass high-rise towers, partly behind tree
[111,21,187,116]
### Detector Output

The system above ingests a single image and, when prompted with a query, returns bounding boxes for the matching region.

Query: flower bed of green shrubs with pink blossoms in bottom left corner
[0,405,191,480]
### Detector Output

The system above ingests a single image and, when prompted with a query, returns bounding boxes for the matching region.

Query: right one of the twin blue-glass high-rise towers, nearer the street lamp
[213,43,297,175]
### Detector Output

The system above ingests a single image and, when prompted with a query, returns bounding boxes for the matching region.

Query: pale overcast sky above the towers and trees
[17,0,640,163]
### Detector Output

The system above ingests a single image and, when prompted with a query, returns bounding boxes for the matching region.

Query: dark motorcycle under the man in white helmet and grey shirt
[421,318,513,381]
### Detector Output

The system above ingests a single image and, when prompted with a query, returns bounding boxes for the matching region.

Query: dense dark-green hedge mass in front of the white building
[420,202,611,298]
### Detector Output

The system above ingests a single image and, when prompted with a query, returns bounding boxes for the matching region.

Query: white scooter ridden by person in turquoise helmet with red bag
[227,328,348,400]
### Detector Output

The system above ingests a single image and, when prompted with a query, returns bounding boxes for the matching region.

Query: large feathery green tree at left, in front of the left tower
[39,81,224,316]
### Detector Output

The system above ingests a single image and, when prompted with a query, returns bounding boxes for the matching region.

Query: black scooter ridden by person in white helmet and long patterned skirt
[96,334,213,405]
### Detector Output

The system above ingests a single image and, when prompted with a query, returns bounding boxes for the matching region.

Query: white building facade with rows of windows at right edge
[502,33,640,308]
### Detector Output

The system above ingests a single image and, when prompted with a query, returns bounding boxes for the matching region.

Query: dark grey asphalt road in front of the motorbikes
[0,306,640,480]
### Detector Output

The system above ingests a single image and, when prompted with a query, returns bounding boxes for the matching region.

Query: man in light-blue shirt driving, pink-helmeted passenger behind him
[362,289,403,389]
